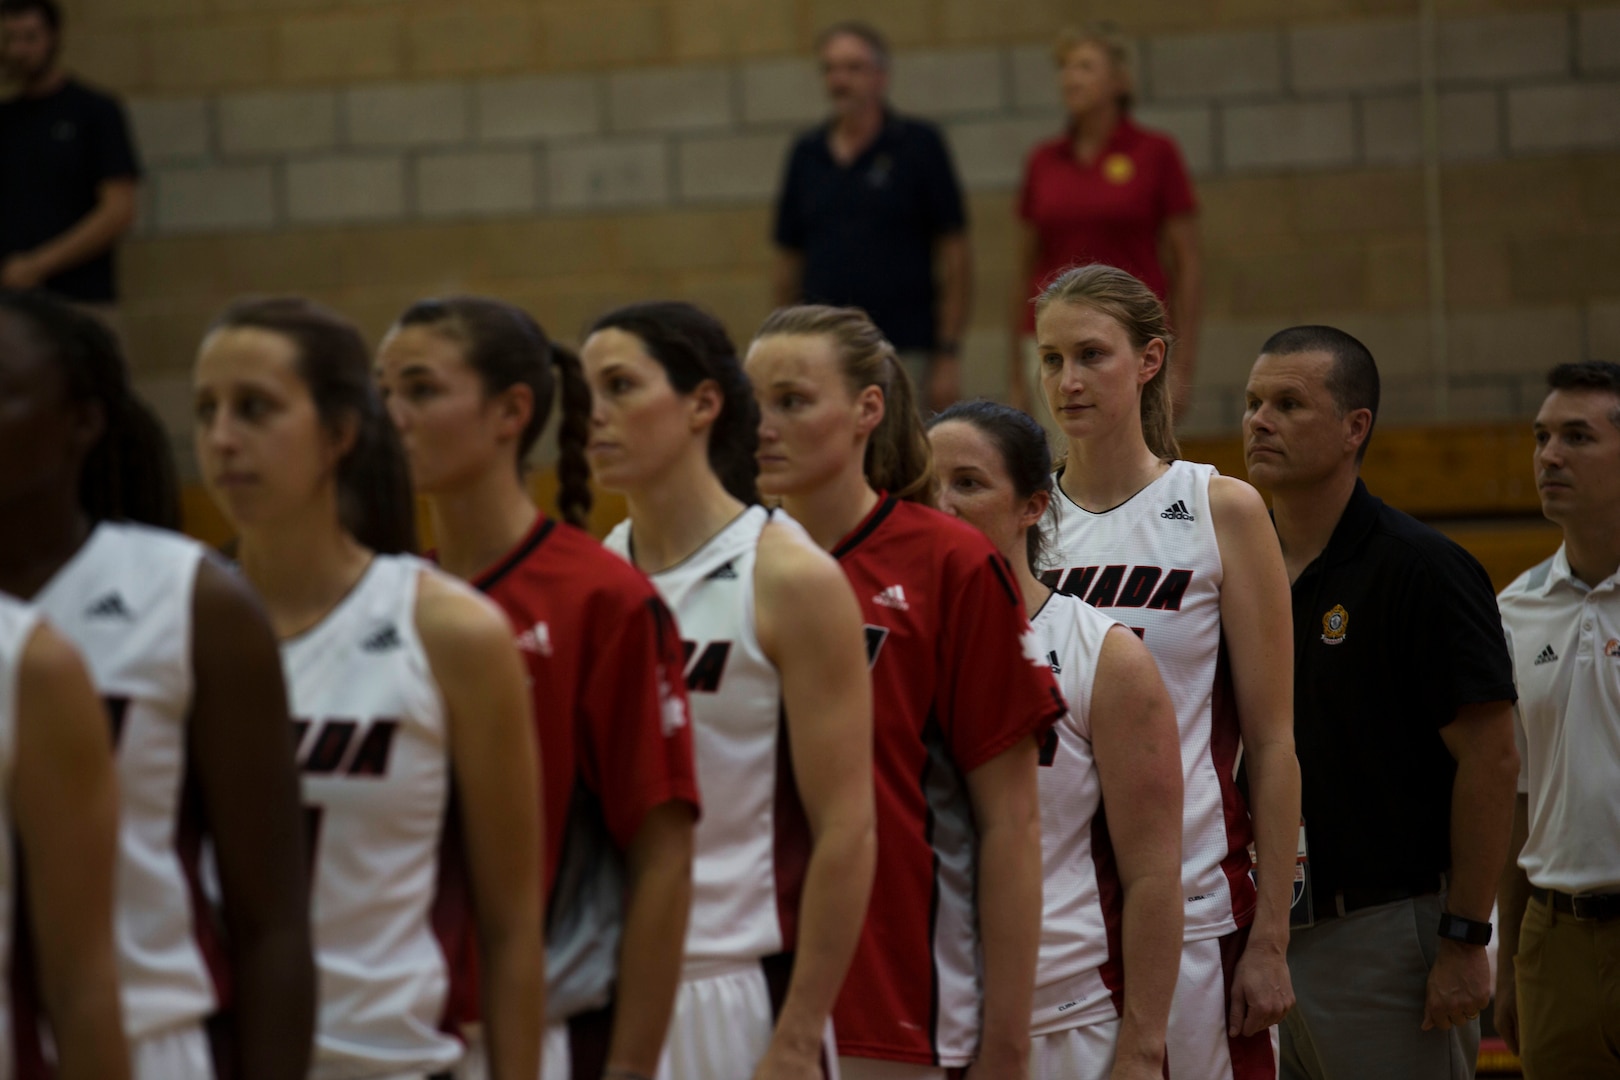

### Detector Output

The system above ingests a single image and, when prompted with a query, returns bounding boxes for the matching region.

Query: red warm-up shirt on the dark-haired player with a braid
[443,515,698,1020]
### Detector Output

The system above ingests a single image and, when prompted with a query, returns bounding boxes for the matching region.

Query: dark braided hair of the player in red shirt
[397,296,591,525]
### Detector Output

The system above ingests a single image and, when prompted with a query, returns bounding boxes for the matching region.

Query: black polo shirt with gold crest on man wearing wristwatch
[1293,479,1518,893]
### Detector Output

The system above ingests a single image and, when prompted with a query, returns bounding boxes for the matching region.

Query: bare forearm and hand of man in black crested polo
[1422,701,1518,1031]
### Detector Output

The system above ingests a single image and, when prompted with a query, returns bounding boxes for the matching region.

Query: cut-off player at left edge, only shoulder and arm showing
[0,596,130,1080]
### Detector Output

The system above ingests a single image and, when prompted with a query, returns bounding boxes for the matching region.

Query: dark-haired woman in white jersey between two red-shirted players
[582,303,873,1080]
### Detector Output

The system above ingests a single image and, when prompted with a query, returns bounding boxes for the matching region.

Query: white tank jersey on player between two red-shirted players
[606,507,808,978]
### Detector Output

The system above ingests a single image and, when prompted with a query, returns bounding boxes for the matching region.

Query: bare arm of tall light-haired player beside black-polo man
[1210,476,1299,1036]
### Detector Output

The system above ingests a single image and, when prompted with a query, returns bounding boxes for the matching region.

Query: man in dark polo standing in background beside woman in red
[776,23,972,410]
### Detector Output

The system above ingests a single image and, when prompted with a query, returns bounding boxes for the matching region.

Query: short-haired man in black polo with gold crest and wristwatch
[1243,327,1518,1080]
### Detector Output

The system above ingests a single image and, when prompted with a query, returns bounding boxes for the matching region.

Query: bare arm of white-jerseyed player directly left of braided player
[416,573,546,1080]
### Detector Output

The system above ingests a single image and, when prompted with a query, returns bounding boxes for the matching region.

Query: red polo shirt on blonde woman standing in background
[1019,118,1199,332]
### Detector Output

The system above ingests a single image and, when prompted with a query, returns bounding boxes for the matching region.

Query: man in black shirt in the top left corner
[0,0,141,309]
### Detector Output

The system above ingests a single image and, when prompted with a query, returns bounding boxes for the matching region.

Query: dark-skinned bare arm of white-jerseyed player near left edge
[190,559,316,1080]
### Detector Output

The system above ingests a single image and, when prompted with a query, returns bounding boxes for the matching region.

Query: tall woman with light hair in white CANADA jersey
[1035,266,1299,1080]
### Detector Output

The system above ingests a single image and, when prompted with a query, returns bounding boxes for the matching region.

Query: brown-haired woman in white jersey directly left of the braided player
[193,298,543,1080]
